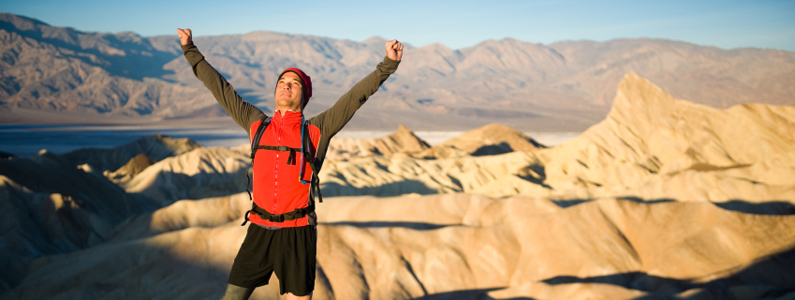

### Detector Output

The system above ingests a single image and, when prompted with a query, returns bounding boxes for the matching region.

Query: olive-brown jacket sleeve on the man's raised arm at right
[316,57,400,139]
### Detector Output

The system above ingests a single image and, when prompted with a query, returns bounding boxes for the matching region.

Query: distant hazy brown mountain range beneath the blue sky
[0,14,795,131]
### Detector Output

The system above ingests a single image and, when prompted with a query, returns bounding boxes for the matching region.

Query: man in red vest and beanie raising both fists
[177,28,403,299]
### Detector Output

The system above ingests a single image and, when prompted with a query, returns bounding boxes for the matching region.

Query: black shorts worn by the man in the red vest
[228,224,317,296]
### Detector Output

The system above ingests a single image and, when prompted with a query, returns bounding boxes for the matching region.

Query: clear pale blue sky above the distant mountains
[0,0,795,51]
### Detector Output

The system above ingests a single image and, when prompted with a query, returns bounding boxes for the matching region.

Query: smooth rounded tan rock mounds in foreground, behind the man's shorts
[3,194,795,299]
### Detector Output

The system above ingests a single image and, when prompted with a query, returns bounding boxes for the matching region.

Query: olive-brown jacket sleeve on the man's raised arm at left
[182,42,265,137]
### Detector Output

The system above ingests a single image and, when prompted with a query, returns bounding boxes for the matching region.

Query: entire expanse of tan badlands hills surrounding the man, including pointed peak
[0,74,795,299]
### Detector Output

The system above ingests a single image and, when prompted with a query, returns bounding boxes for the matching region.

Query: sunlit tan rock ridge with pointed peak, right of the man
[320,74,795,204]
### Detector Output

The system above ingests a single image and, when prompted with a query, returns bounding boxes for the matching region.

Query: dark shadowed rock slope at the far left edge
[0,151,160,292]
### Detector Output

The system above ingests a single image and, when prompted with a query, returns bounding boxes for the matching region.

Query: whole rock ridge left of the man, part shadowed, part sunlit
[0,135,241,290]
